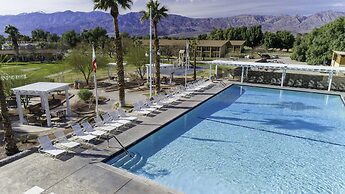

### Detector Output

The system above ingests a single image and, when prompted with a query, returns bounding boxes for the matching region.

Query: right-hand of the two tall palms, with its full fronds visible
[141,0,168,93]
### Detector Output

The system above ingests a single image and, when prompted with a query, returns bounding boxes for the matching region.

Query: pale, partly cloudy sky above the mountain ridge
[0,0,345,17]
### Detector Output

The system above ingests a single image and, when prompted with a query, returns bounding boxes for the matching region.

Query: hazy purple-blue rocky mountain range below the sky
[0,11,345,36]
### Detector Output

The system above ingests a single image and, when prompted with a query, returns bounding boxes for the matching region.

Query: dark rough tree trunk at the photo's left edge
[0,79,19,156]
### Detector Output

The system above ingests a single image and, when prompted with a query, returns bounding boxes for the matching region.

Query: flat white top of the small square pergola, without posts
[12,82,69,95]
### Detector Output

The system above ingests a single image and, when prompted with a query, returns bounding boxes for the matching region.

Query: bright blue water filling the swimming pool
[108,85,345,194]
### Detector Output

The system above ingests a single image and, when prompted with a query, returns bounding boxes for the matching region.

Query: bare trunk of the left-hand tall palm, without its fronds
[111,7,126,107]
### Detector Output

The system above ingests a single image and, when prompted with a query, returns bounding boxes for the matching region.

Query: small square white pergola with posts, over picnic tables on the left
[12,82,71,126]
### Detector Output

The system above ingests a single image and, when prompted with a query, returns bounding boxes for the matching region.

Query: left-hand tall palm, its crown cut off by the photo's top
[93,0,133,107]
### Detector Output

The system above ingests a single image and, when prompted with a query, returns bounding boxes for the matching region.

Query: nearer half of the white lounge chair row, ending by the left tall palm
[38,109,137,158]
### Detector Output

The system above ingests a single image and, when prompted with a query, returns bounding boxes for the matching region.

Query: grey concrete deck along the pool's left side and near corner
[0,82,230,194]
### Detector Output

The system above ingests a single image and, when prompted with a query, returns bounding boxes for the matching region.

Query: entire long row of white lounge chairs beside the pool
[38,80,213,158]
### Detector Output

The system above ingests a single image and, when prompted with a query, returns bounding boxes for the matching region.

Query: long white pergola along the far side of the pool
[207,60,345,91]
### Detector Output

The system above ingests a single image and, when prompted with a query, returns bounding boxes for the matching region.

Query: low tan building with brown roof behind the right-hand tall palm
[143,39,245,58]
